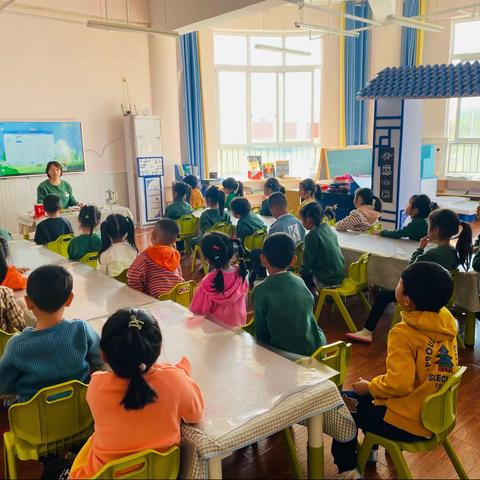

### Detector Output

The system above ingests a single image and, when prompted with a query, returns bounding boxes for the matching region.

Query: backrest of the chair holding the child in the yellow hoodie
[421,367,467,436]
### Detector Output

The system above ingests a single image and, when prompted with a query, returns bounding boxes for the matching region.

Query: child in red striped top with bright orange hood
[128,218,183,298]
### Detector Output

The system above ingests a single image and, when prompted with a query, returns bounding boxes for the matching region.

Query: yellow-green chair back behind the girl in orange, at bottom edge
[92,447,180,480]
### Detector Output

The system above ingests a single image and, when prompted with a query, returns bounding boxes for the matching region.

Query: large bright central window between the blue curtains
[214,33,322,176]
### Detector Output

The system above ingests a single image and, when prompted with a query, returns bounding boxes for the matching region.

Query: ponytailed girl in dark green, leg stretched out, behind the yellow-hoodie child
[346,209,472,343]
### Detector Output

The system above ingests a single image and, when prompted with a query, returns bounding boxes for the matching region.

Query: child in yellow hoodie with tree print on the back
[332,262,458,478]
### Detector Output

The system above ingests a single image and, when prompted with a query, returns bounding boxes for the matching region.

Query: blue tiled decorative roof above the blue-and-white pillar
[357,61,480,99]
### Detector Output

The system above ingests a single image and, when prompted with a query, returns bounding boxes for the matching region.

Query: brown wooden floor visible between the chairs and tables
[0,225,480,479]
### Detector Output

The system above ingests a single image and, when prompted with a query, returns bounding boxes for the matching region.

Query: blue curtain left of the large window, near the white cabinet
[180,32,205,178]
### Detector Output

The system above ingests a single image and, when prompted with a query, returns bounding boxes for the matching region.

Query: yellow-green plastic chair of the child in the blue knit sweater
[3,380,93,480]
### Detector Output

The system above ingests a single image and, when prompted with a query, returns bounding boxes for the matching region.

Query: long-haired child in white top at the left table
[97,213,138,277]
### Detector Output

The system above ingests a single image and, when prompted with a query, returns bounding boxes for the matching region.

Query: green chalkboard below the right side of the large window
[326,147,372,177]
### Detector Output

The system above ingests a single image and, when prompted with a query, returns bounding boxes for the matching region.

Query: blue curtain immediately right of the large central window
[344,1,371,146]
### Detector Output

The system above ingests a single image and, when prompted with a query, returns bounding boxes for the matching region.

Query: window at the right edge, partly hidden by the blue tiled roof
[445,20,480,177]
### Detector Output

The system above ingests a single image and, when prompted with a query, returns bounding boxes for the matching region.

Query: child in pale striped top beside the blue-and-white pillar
[335,188,382,232]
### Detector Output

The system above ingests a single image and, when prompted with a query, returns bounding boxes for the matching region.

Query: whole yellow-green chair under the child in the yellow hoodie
[357,367,468,479]
